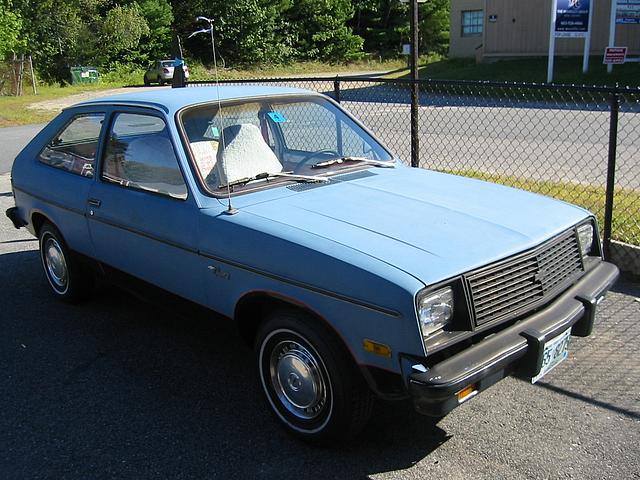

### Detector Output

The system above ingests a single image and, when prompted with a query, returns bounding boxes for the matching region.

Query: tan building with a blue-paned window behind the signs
[449,0,640,61]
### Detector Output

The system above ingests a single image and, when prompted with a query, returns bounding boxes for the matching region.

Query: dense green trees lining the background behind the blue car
[8,0,448,81]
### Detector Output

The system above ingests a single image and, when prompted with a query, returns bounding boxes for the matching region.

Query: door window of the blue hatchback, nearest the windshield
[101,113,187,199]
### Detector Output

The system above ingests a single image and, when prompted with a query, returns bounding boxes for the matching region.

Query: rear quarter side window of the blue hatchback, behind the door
[38,113,104,178]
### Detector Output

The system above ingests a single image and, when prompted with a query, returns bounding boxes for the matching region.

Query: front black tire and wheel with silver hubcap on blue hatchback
[255,310,374,445]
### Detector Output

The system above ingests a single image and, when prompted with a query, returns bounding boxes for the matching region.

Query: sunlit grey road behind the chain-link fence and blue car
[0,86,640,189]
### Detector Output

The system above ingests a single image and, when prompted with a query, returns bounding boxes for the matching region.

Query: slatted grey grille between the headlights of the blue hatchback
[465,230,584,325]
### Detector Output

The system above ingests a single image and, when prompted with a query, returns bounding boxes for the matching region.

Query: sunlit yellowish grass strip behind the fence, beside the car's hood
[445,170,640,245]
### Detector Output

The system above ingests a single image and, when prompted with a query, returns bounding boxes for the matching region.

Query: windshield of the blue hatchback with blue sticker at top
[180,96,393,194]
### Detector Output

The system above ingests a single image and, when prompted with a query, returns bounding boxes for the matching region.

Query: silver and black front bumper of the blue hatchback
[407,262,619,416]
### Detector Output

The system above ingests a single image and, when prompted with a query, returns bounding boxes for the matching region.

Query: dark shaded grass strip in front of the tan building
[390,57,640,87]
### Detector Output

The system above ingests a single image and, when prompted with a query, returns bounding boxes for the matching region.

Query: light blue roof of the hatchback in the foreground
[72,85,316,113]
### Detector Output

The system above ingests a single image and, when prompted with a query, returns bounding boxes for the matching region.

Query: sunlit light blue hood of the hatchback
[242,167,589,284]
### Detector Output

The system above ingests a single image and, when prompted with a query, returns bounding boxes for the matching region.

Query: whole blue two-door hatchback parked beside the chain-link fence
[7,86,618,442]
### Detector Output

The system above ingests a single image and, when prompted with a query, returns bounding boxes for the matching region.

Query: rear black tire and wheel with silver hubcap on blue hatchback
[38,223,95,303]
